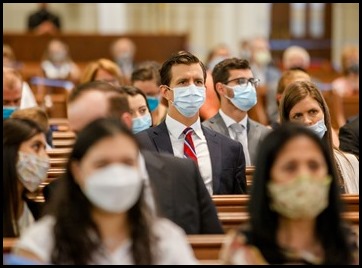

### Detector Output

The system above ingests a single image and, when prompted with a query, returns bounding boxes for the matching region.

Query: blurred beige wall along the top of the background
[3,3,359,67]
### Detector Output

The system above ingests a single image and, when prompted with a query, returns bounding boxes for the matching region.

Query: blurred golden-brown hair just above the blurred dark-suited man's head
[80,58,125,87]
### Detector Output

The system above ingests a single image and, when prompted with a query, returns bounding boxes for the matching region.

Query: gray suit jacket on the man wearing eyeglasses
[202,113,271,165]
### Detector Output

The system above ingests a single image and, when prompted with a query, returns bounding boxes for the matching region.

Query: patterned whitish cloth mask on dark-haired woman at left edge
[16,151,50,192]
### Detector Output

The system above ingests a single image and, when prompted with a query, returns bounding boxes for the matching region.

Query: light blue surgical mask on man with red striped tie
[173,84,206,117]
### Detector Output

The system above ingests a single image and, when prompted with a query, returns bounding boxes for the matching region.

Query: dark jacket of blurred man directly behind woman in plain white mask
[43,151,224,234]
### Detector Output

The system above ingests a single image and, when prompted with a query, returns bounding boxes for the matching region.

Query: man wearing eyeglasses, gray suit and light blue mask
[203,58,270,166]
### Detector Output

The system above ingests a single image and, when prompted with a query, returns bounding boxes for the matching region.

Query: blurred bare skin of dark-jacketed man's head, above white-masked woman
[68,90,109,133]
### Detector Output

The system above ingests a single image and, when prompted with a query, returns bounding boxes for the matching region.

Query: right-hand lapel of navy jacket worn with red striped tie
[201,126,222,193]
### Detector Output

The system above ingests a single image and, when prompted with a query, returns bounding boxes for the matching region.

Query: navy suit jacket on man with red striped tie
[136,121,246,195]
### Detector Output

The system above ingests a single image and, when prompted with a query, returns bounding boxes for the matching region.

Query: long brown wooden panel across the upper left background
[3,32,188,62]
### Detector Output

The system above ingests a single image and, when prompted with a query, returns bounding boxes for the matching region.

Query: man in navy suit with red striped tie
[136,51,246,195]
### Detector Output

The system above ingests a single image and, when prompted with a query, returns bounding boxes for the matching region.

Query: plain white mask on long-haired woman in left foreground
[82,164,142,213]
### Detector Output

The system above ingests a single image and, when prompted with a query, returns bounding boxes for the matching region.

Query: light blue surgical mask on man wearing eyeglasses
[225,82,257,112]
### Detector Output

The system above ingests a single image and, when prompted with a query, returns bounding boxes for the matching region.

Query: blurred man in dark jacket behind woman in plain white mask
[44,81,223,234]
